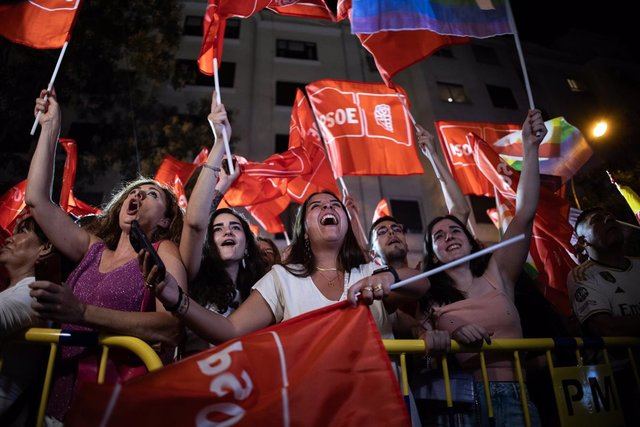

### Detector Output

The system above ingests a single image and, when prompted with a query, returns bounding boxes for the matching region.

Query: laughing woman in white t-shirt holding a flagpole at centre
[139,192,428,344]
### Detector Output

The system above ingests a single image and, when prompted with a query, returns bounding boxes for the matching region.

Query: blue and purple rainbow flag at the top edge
[351,0,513,38]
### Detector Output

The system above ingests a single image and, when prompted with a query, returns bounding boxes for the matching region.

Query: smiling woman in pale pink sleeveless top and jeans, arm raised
[421,110,546,426]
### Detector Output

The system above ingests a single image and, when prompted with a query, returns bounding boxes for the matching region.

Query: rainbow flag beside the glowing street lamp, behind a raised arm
[492,117,593,182]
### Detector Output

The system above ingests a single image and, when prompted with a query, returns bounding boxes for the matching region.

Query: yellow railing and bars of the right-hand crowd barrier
[383,337,640,427]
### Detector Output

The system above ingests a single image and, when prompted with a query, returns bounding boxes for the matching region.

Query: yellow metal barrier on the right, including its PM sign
[383,337,640,427]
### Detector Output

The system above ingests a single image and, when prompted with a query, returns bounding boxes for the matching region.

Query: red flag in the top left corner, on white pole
[0,0,80,49]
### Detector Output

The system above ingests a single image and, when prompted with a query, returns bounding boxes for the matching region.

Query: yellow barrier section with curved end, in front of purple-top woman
[0,328,162,427]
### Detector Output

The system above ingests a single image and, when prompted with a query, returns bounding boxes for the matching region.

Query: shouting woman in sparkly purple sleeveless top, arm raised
[26,91,186,420]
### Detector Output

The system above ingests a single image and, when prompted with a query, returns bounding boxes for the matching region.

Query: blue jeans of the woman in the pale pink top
[426,381,541,427]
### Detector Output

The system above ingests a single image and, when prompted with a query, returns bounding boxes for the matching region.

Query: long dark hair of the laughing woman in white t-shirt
[283,191,367,277]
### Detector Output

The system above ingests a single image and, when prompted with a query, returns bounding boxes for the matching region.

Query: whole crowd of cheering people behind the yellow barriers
[0,91,640,426]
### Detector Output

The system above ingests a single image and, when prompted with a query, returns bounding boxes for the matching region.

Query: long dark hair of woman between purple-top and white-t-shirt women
[189,208,269,313]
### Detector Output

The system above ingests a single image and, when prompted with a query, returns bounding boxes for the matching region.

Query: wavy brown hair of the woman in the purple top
[87,178,182,250]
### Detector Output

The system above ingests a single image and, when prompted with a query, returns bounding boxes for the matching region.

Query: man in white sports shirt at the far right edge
[567,207,640,336]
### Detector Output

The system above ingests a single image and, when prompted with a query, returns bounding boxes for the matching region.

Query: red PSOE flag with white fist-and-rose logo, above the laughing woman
[306,80,424,176]
